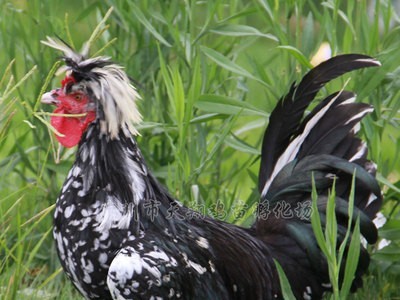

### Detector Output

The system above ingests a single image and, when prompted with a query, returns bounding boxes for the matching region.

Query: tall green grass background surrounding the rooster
[0,0,400,299]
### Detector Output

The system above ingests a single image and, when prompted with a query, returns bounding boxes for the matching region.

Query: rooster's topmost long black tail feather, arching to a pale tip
[259,54,380,194]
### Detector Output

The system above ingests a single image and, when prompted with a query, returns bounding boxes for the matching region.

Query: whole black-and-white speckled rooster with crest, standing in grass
[42,38,382,299]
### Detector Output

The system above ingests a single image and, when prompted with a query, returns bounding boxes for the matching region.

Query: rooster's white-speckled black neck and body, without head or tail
[54,120,279,299]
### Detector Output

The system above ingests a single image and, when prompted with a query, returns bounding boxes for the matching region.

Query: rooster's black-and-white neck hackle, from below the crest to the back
[70,122,179,229]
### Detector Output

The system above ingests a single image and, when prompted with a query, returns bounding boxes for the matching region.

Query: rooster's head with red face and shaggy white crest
[42,38,141,147]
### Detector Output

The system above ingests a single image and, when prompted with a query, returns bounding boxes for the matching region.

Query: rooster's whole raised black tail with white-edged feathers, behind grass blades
[254,54,382,299]
